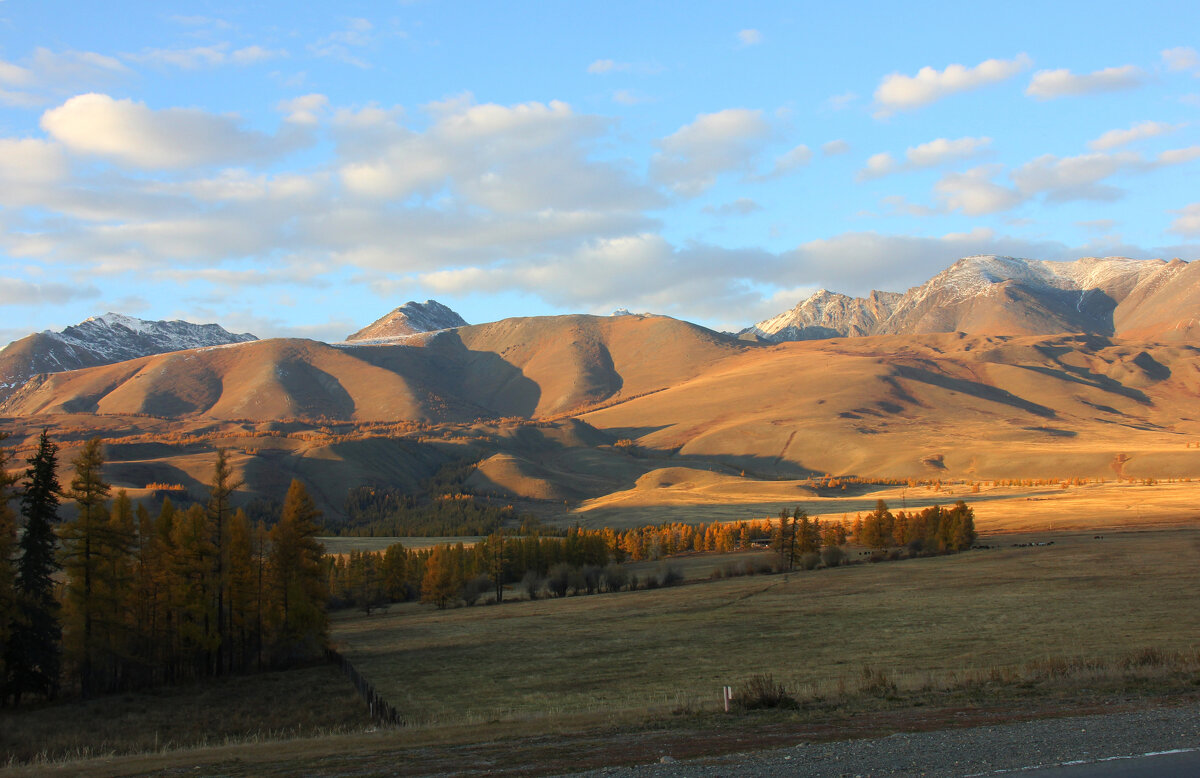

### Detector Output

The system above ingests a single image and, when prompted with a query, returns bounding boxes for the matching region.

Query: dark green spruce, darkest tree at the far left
[5,430,62,704]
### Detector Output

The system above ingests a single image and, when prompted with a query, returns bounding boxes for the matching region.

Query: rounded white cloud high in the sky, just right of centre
[650,108,770,197]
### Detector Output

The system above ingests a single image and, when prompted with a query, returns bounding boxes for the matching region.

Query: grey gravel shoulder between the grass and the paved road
[566,706,1200,778]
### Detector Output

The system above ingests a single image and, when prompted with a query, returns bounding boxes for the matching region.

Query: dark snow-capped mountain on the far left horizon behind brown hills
[0,313,258,399]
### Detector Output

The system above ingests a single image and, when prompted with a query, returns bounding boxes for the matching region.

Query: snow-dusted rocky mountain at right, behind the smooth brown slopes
[744,255,1200,341]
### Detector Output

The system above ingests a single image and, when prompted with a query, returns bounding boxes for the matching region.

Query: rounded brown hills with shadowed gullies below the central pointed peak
[0,316,749,421]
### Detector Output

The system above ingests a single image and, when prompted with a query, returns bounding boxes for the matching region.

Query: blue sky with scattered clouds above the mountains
[0,0,1200,342]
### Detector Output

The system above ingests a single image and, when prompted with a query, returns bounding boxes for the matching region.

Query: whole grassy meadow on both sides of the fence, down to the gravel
[9,528,1200,776]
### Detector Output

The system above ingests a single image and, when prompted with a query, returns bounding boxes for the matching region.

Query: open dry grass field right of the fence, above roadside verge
[334,529,1200,726]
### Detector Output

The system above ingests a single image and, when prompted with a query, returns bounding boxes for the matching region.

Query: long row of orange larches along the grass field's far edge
[326,501,976,612]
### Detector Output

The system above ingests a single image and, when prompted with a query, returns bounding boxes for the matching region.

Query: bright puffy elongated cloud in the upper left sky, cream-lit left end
[41,92,294,168]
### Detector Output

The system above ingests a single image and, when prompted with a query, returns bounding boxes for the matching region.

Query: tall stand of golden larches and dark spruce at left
[0,431,328,704]
